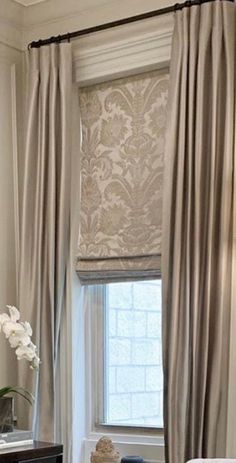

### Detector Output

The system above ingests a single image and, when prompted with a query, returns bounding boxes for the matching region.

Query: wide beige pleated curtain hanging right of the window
[162,0,236,463]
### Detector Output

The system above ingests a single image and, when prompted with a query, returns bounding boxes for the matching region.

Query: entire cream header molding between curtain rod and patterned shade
[73,15,173,86]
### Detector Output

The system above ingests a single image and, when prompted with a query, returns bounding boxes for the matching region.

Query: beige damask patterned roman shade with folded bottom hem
[77,71,168,283]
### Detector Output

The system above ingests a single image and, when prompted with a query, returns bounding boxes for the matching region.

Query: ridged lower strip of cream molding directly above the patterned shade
[74,30,172,86]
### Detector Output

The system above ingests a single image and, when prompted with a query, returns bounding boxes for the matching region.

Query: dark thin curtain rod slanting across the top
[28,0,234,49]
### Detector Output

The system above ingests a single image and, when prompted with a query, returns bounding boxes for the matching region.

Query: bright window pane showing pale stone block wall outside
[104,280,163,427]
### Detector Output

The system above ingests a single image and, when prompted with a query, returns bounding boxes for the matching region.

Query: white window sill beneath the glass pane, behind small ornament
[84,432,164,463]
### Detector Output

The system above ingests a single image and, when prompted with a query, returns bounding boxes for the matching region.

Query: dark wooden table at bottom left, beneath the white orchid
[0,441,63,463]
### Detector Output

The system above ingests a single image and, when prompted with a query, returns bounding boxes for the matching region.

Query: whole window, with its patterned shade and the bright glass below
[80,69,168,446]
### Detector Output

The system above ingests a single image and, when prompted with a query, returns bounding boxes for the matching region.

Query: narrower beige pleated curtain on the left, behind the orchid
[18,44,79,441]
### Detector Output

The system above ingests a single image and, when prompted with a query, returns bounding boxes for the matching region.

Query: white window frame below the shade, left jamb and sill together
[84,285,164,462]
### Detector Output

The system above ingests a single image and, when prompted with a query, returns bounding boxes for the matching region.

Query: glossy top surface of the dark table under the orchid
[0,441,63,461]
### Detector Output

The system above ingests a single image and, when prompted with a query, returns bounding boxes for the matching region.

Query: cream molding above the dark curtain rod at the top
[23,0,173,48]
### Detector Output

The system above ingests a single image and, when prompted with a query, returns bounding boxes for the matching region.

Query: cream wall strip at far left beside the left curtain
[0,0,22,387]
